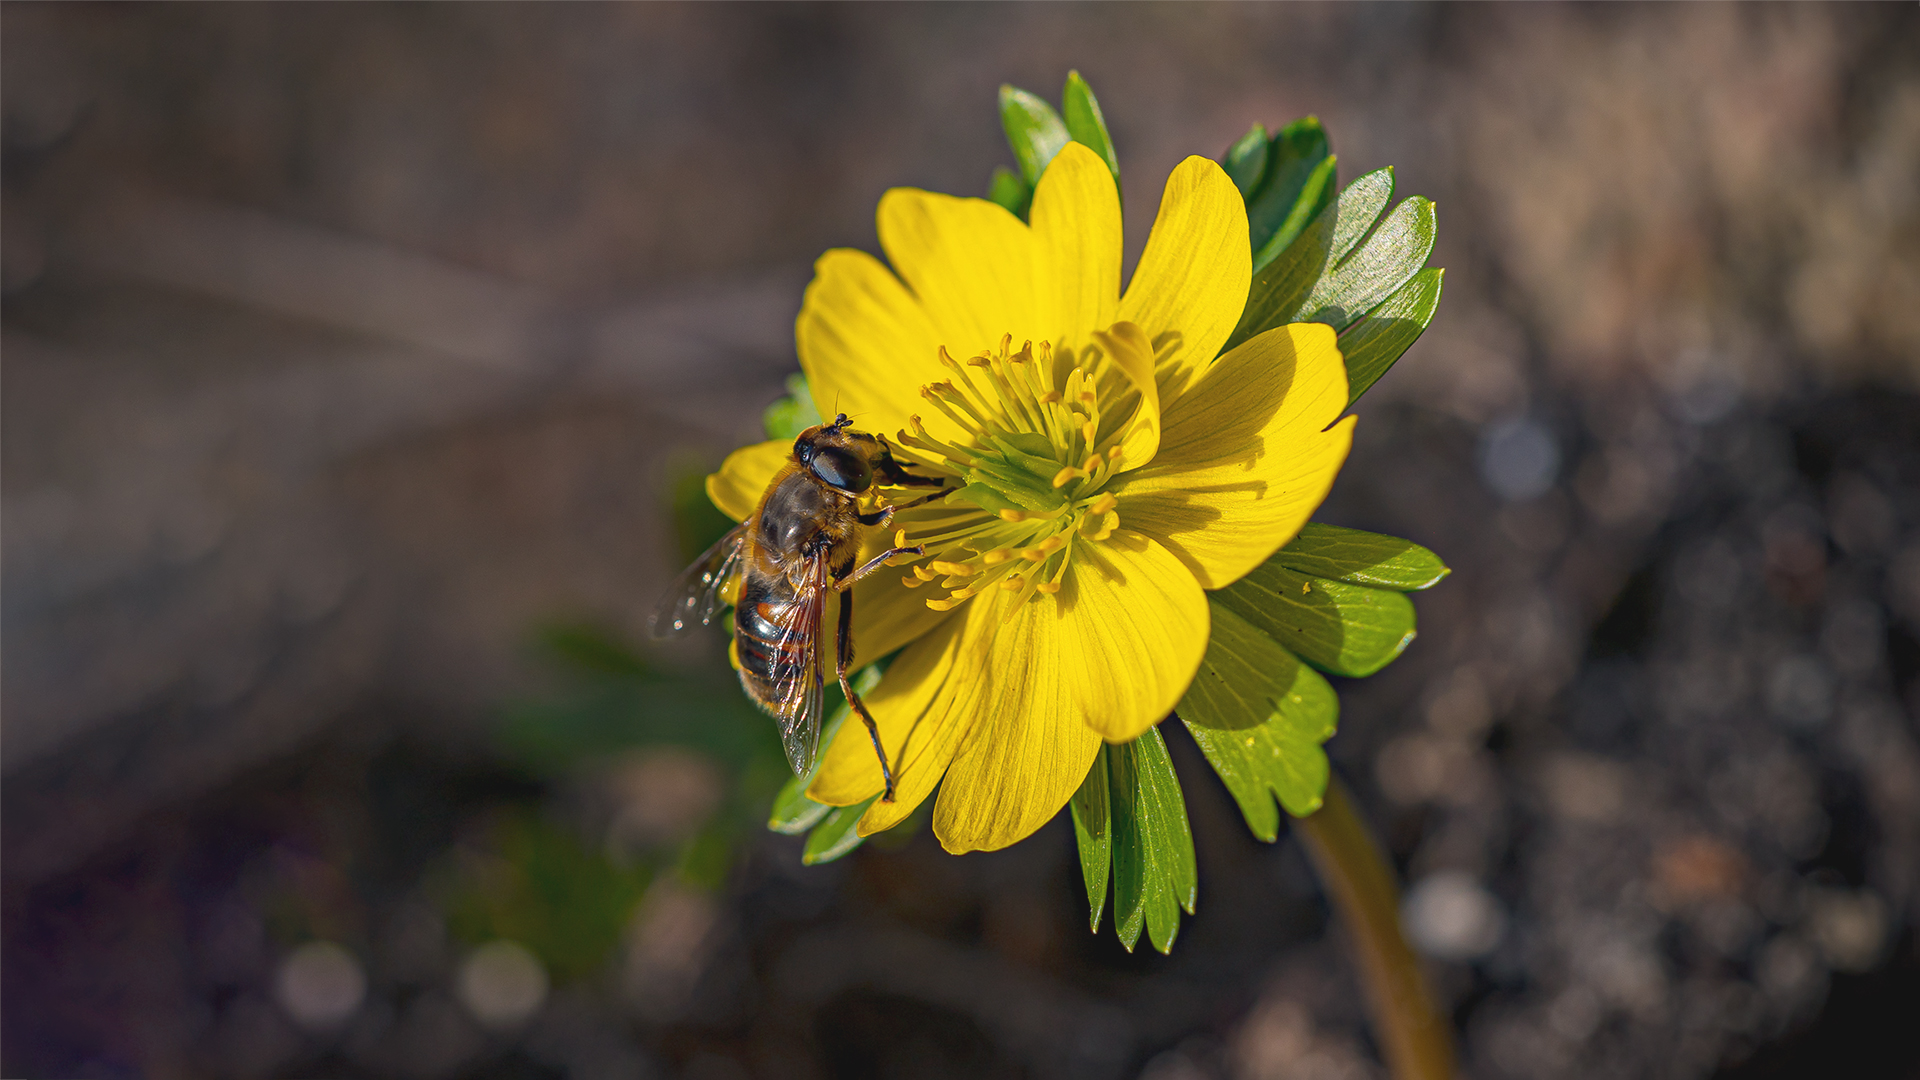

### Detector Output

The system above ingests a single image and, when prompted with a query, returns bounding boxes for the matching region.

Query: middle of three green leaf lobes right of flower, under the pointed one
[1212,559,1413,676]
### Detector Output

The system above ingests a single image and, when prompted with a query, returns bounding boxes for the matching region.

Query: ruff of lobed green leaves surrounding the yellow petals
[748,73,1448,951]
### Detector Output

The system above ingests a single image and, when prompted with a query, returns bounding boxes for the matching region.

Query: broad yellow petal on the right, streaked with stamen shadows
[1110,323,1354,588]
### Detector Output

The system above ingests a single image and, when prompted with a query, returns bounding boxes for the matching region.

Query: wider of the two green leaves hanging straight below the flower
[1106,728,1200,953]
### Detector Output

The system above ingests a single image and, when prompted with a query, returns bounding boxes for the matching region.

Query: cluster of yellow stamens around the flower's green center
[879,327,1158,617]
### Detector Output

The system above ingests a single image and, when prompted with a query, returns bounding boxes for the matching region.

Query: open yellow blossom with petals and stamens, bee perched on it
[708,142,1354,853]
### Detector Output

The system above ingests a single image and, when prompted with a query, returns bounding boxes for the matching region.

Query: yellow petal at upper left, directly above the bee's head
[793,248,947,436]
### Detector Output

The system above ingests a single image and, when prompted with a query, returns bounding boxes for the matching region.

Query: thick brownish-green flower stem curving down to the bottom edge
[1296,776,1453,1080]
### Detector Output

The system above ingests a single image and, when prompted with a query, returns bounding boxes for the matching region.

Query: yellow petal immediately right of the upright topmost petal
[1119,158,1254,407]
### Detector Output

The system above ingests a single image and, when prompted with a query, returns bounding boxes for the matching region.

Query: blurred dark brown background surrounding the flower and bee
[0,4,1920,1080]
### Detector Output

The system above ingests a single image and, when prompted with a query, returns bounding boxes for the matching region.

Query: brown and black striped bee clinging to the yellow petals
[651,413,945,803]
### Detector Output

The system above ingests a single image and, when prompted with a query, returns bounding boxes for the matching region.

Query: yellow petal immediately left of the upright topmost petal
[879,188,1044,365]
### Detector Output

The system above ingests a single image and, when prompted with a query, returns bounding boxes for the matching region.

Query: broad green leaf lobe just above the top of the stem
[1177,600,1340,842]
